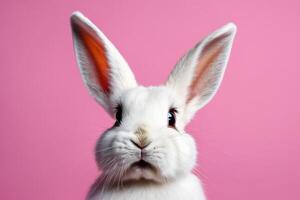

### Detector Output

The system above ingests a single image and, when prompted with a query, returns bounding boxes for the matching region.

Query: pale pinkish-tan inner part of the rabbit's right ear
[187,42,223,103]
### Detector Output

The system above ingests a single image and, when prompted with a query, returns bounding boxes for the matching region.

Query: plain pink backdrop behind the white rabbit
[0,0,300,200]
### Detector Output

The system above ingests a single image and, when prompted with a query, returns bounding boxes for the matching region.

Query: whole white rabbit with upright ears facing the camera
[71,12,236,200]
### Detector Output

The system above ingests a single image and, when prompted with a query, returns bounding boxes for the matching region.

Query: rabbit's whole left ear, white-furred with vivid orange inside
[71,12,137,115]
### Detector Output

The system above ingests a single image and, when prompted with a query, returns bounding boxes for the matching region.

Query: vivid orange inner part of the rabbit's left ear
[77,24,110,94]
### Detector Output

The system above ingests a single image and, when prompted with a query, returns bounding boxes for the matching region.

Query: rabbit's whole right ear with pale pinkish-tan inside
[166,23,236,122]
